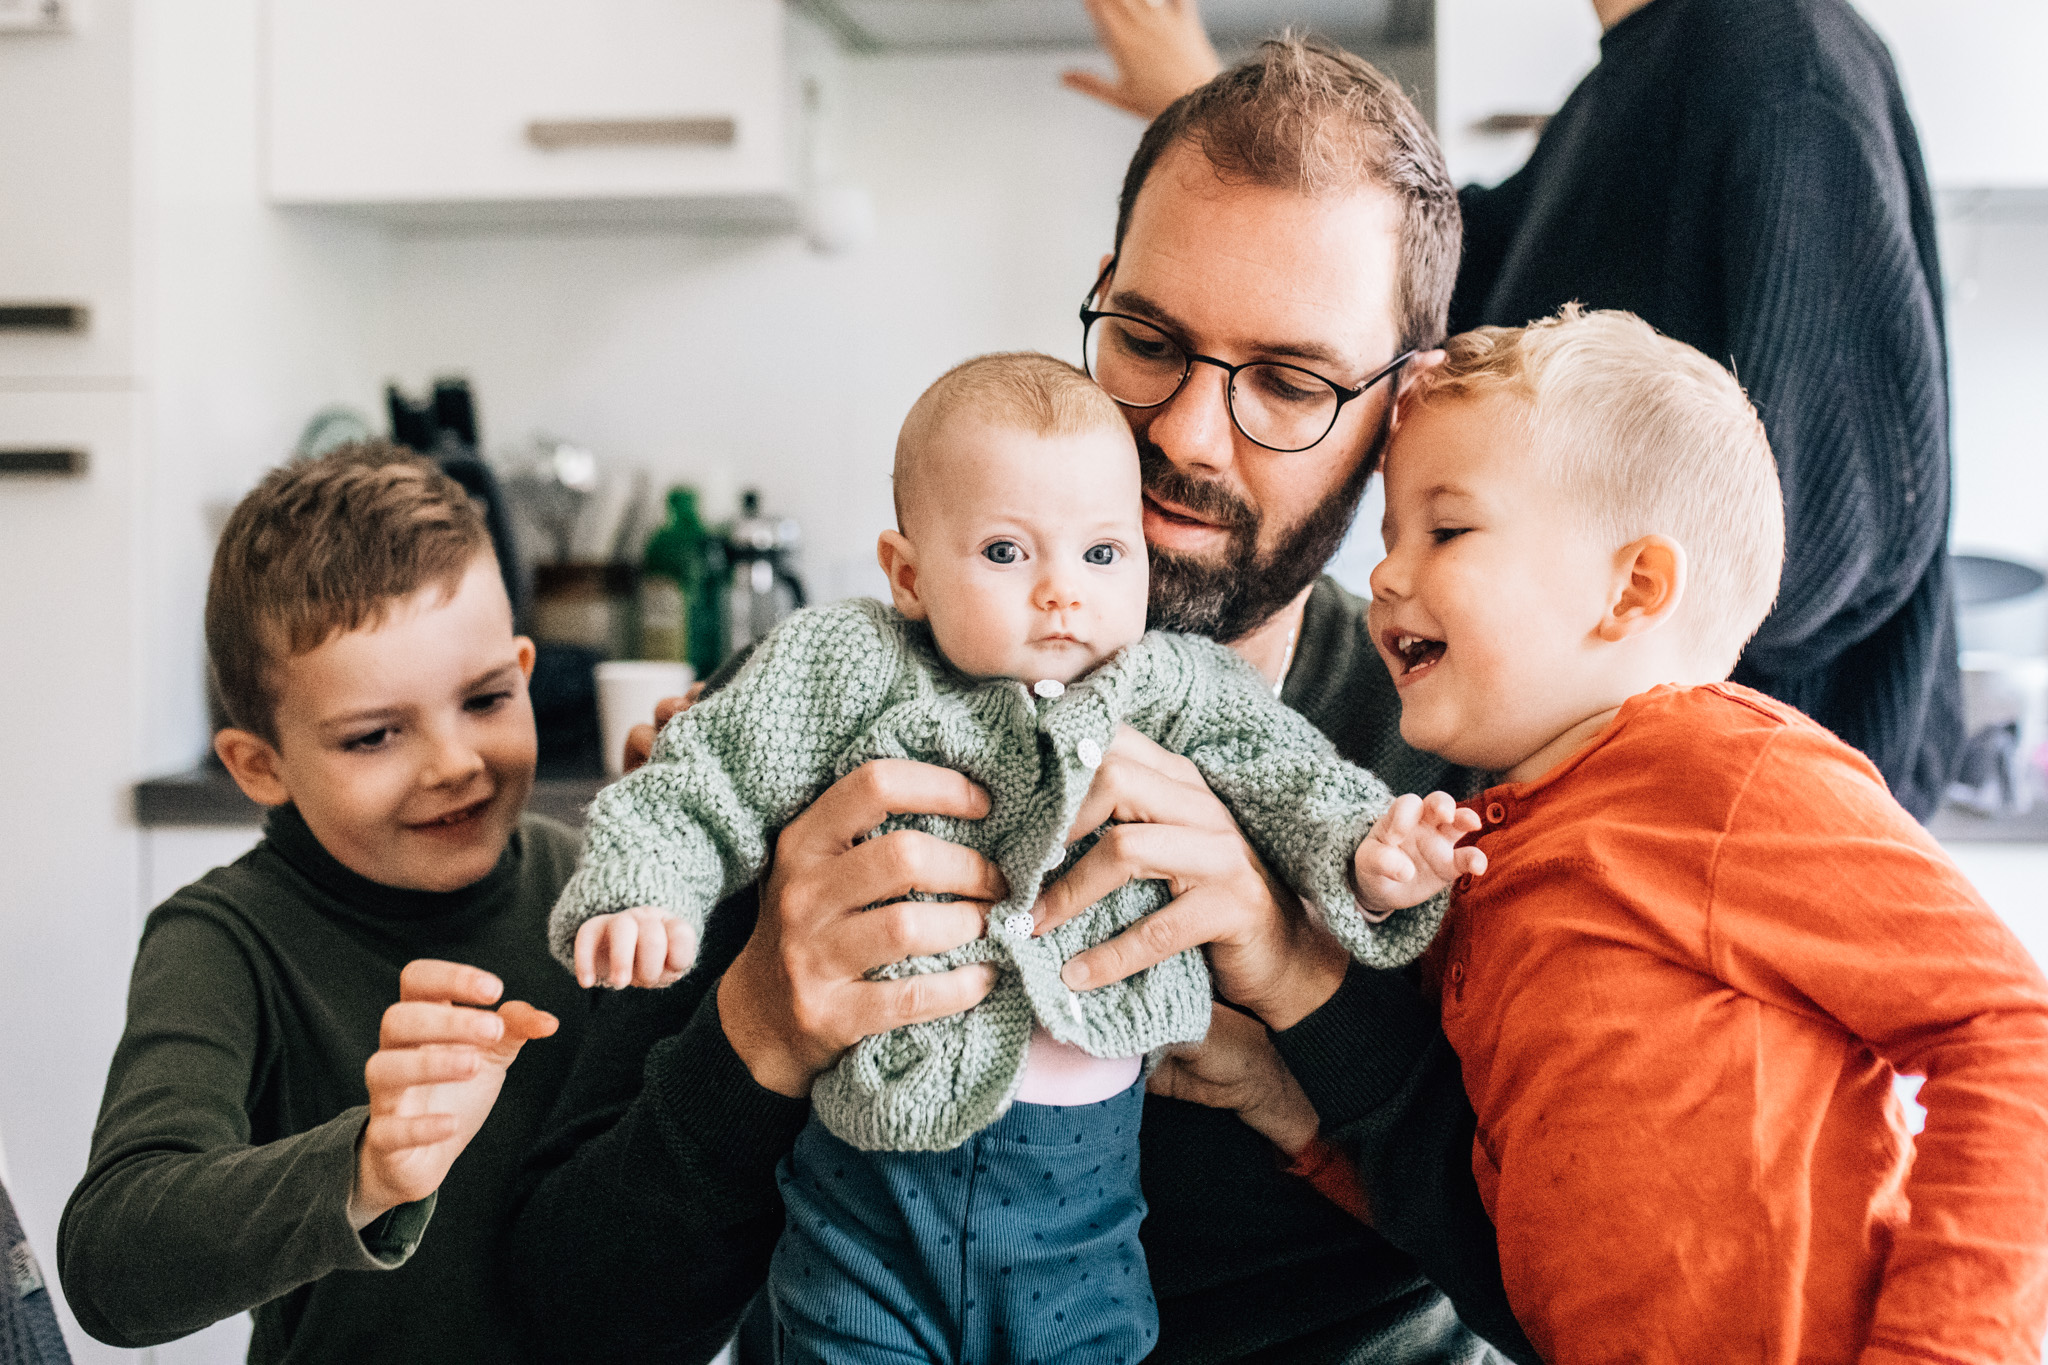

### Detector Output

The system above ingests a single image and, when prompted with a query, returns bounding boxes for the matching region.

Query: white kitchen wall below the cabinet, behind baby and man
[377,53,1141,598]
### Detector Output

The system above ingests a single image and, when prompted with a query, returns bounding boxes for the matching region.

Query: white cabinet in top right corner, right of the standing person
[1855,0,2048,190]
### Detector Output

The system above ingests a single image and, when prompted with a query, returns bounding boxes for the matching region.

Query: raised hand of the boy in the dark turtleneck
[348,958,559,1232]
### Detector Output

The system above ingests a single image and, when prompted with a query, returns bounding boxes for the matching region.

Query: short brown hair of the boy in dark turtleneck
[207,440,492,743]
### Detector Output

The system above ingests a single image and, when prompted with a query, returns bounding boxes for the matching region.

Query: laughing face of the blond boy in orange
[1366,397,1618,772]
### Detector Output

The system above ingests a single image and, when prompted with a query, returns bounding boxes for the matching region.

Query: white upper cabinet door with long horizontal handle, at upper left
[278,0,791,207]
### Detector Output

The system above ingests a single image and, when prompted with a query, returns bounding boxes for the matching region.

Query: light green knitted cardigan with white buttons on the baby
[549,600,1446,1150]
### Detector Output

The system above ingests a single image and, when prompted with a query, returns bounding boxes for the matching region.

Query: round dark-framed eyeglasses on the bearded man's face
[1081,260,1415,452]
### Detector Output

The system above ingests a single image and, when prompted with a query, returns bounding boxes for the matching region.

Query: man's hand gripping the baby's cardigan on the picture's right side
[1036,726,1350,1029]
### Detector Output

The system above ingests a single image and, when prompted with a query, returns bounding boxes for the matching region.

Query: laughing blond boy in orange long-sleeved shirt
[1370,309,2048,1365]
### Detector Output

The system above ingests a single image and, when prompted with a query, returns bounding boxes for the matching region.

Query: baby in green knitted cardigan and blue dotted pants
[551,354,1483,1363]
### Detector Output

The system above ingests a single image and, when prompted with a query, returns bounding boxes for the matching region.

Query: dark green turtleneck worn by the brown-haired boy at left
[57,806,586,1365]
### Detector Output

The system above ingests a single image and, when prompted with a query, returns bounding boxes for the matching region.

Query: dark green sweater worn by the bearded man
[512,579,1534,1365]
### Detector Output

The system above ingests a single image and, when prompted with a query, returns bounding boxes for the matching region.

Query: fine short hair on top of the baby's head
[893,350,1130,532]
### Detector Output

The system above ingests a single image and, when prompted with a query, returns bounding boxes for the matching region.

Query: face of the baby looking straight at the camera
[893,415,1147,681]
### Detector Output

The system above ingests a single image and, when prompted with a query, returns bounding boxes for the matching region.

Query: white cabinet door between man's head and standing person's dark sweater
[1436,0,1599,184]
